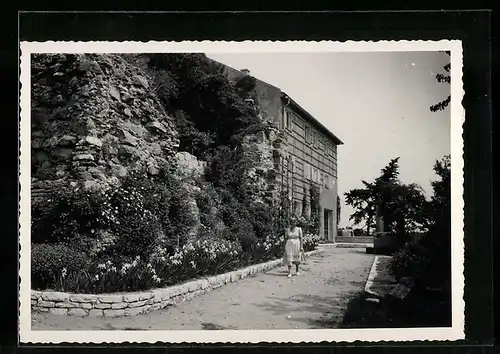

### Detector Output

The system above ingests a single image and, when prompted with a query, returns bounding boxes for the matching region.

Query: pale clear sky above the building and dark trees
[207,52,451,227]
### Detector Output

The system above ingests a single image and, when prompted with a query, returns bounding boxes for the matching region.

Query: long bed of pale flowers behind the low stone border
[32,234,319,294]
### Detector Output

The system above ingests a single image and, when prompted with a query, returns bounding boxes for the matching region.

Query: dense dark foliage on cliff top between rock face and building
[148,53,265,158]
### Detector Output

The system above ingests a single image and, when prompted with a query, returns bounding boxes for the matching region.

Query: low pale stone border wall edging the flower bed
[31,248,321,317]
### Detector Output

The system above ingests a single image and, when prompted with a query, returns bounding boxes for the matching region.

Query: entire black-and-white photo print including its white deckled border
[20,41,464,343]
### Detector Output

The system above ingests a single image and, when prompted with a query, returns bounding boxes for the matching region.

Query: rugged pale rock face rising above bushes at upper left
[31,54,178,198]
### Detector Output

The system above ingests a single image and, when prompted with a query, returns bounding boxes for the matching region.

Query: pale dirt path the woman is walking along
[32,247,374,330]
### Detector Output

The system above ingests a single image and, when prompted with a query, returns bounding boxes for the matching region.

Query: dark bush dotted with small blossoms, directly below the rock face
[32,171,195,257]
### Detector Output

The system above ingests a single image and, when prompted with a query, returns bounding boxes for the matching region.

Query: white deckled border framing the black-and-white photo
[19,40,465,343]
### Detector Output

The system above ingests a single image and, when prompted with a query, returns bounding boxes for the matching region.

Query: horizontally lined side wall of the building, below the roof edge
[219,62,338,241]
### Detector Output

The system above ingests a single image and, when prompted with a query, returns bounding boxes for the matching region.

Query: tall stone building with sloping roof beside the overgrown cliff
[223,65,343,241]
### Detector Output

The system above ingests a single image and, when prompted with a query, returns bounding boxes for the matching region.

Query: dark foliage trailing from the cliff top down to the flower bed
[148,53,273,250]
